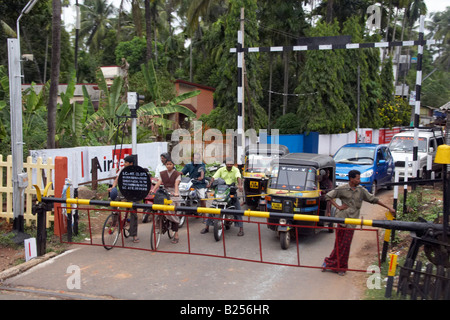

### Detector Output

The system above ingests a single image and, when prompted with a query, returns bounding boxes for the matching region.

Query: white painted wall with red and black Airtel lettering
[30,142,168,187]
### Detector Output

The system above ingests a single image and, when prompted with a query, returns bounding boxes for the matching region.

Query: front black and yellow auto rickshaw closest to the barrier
[265,153,336,249]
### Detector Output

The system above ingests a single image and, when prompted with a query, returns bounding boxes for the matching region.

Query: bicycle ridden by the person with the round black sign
[102,210,130,250]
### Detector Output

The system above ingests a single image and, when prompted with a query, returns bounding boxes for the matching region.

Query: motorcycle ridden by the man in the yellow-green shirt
[210,178,237,241]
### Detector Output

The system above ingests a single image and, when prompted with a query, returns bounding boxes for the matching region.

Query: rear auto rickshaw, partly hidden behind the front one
[243,144,289,211]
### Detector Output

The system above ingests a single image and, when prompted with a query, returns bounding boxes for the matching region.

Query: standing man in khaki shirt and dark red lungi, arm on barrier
[322,170,395,276]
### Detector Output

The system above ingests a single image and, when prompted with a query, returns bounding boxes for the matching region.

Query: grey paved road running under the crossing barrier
[0,191,391,300]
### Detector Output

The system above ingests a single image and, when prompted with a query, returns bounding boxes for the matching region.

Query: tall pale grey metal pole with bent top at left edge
[8,0,38,243]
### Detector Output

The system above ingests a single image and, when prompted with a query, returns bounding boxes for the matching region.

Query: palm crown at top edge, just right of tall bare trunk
[80,0,116,53]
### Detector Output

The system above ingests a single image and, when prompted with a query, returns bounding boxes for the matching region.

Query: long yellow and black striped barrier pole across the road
[38,197,443,232]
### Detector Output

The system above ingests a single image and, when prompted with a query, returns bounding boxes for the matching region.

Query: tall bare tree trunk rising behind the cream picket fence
[47,0,61,149]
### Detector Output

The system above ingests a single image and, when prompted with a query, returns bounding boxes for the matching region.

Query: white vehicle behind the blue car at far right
[389,127,444,179]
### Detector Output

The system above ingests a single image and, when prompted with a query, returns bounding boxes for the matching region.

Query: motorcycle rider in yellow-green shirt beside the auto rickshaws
[200,159,244,237]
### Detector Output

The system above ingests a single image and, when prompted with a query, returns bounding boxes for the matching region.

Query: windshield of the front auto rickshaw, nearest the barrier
[270,165,317,191]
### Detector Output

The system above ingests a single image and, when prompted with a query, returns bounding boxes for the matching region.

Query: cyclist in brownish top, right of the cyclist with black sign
[152,158,181,243]
